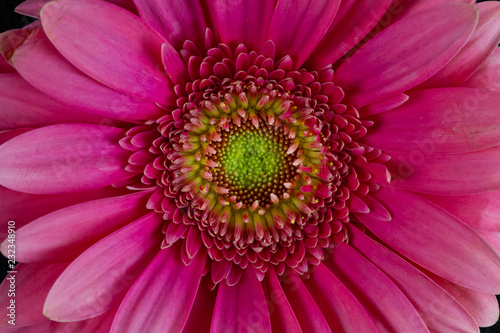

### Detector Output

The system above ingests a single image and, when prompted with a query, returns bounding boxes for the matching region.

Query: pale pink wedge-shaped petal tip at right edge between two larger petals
[424,190,500,232]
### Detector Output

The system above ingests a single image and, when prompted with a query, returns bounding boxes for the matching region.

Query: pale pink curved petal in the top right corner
[419,1,500,89]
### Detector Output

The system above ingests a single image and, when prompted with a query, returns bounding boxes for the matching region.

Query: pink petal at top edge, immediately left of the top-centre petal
[133,0,207,50]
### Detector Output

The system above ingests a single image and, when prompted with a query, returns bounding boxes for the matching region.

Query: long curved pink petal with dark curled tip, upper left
[0,26,160,119]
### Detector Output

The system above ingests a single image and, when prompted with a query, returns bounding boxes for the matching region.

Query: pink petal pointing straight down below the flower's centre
[210,269,271,333]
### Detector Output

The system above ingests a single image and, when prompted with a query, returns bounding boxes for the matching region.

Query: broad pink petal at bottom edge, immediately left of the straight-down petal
[111,246,205,332]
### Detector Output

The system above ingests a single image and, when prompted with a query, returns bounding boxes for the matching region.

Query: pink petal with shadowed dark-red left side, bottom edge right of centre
[305,264,378,333]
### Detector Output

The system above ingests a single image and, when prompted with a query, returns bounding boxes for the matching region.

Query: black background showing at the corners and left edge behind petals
[0,0,500,333]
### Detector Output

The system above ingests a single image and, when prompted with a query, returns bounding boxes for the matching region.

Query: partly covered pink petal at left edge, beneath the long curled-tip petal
[0,74,108,130]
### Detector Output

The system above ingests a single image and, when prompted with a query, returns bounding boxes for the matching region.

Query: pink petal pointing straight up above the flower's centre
[207,0,275,52]
